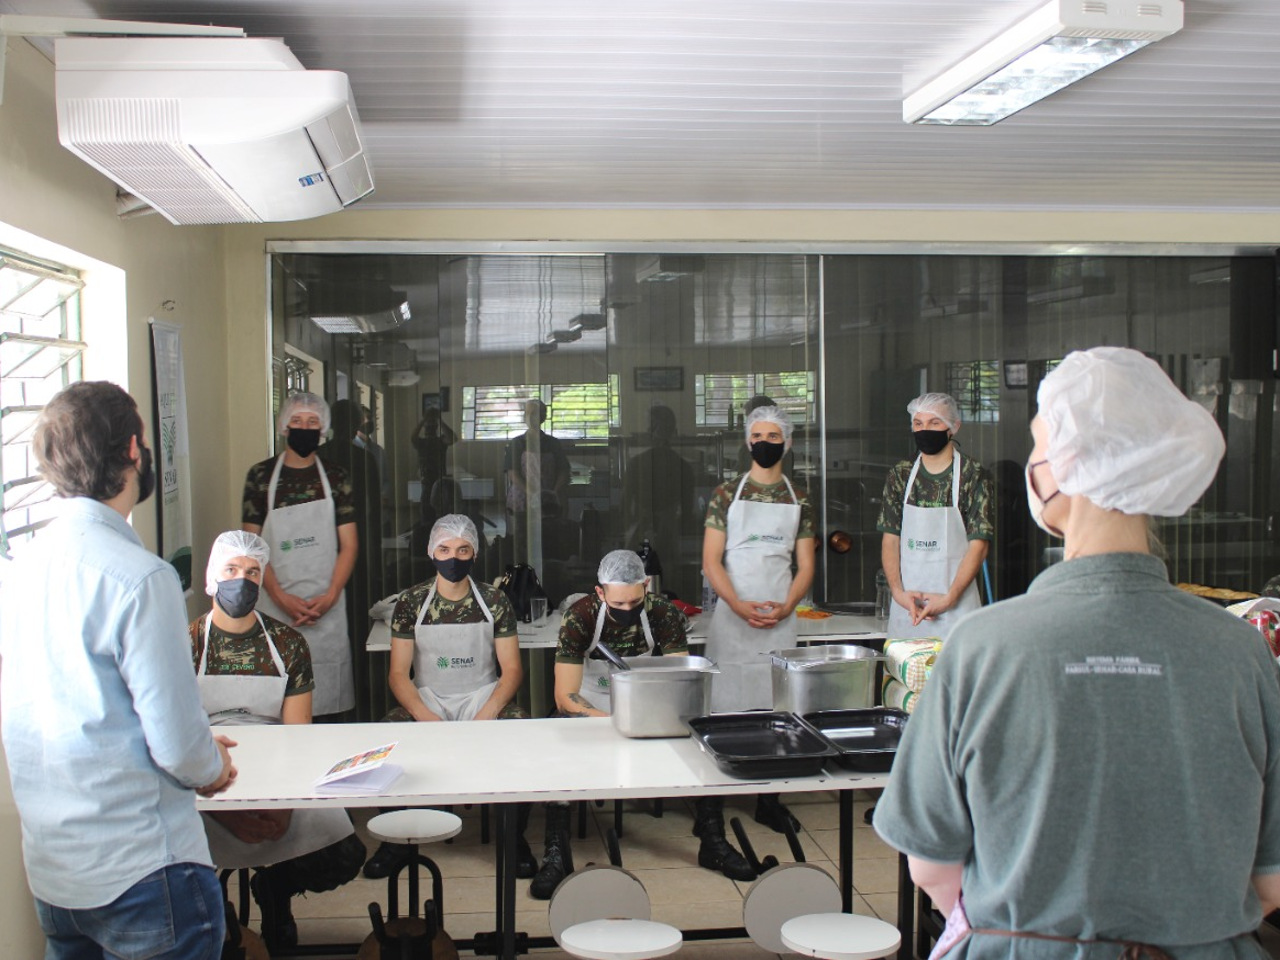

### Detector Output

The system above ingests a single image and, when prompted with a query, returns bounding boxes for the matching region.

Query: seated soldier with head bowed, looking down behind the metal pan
[529,550,755,900]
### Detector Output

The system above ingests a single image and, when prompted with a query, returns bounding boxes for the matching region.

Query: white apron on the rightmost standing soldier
[886,451,982,640]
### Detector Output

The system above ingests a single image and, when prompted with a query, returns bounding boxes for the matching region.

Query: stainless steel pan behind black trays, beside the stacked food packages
[769,644,884,716]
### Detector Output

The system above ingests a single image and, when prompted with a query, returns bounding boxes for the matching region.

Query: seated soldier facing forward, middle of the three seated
[365,513,538,879]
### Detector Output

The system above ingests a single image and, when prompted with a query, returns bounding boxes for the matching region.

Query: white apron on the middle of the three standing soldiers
[707,475,800,713]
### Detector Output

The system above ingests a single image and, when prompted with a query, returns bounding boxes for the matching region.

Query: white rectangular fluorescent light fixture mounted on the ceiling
[902,0,1183,127]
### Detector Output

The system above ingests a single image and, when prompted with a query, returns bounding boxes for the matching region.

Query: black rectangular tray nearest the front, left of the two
[689,712,836,780]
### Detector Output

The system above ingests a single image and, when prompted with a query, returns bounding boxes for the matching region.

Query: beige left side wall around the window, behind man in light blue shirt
[0,37,231,960]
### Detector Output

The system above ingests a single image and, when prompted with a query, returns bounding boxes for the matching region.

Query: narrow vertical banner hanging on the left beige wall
[151,319,191,593]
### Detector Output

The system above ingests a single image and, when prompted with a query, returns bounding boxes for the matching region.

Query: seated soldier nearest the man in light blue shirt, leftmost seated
[191,530,365,951]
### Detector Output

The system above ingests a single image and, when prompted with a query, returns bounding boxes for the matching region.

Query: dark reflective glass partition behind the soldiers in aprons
[271,252,1280,716]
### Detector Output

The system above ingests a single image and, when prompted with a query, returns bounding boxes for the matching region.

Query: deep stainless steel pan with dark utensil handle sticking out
[609,657,718,737]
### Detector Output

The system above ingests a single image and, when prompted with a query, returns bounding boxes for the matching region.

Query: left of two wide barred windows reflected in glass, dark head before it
[462,374,622,440]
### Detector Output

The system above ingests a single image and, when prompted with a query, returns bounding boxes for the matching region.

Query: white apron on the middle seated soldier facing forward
[413,577,498,721]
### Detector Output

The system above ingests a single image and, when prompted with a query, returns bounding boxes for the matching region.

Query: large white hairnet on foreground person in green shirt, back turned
[1037,347,1226,517]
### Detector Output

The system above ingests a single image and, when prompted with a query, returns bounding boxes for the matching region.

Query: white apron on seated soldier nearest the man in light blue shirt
[196,613,355,870]
